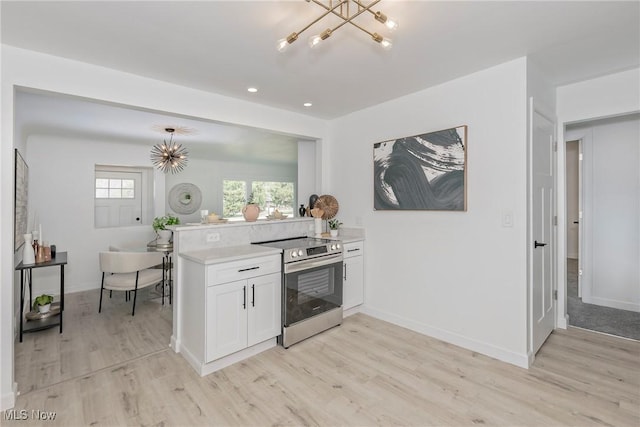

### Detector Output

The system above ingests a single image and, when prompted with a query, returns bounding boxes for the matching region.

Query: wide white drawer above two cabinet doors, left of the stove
[207,255,281,286]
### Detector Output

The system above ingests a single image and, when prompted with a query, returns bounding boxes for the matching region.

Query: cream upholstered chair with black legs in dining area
[98,252,164,316]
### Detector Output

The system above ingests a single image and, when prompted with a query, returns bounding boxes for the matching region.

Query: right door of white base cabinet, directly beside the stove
[247,273,282,346]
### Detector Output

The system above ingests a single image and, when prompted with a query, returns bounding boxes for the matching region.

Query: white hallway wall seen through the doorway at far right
[565,114,640,311]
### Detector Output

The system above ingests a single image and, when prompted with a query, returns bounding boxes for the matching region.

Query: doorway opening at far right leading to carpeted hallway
[565,113,640,340]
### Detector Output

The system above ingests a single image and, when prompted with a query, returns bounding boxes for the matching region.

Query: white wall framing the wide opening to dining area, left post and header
[0,45,329,409]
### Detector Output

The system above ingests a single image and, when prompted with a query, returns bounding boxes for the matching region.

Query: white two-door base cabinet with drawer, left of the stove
[180,254,282,375]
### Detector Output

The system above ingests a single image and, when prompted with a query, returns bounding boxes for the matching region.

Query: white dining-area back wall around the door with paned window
[26,135,164,295]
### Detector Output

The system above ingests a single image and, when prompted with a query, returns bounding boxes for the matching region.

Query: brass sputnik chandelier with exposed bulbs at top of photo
[276,0,398,52]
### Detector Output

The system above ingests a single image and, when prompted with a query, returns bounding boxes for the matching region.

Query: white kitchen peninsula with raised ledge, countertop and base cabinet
[171,218,364,375]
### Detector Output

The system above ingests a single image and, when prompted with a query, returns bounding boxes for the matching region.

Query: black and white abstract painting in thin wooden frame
[373,126,467,211]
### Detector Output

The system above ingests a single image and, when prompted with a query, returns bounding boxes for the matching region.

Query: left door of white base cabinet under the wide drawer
[205,280,248,362]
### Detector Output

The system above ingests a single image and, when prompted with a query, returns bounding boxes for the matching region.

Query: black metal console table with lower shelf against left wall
[16,252,67,342]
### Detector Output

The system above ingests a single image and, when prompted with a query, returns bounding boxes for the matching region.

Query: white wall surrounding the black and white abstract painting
[329,58,527,366]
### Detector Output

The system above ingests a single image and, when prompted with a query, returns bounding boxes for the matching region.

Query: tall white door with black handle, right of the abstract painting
[530,105,555,354]
